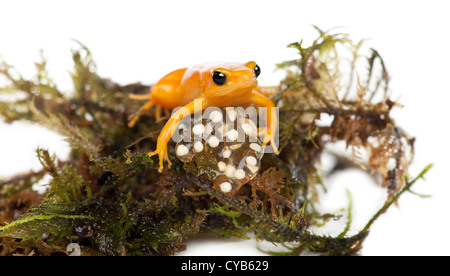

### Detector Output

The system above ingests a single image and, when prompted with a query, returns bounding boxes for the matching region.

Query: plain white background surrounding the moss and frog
[0,0,450,255]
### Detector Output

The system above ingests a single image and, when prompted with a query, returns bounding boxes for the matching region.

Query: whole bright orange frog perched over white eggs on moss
[128,61,279,172]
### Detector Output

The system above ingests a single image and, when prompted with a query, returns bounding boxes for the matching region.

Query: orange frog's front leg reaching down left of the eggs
[148,98,207,173]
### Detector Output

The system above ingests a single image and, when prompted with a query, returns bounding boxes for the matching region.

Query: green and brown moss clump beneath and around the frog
[0,29,428,255]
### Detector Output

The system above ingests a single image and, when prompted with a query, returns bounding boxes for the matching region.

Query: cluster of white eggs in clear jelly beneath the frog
[175,108,264,194]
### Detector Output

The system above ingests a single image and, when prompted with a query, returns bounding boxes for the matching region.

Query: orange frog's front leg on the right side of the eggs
[250,91,280,154]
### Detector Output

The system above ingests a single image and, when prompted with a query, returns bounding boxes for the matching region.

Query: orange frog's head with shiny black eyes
[202,61,261,106]
